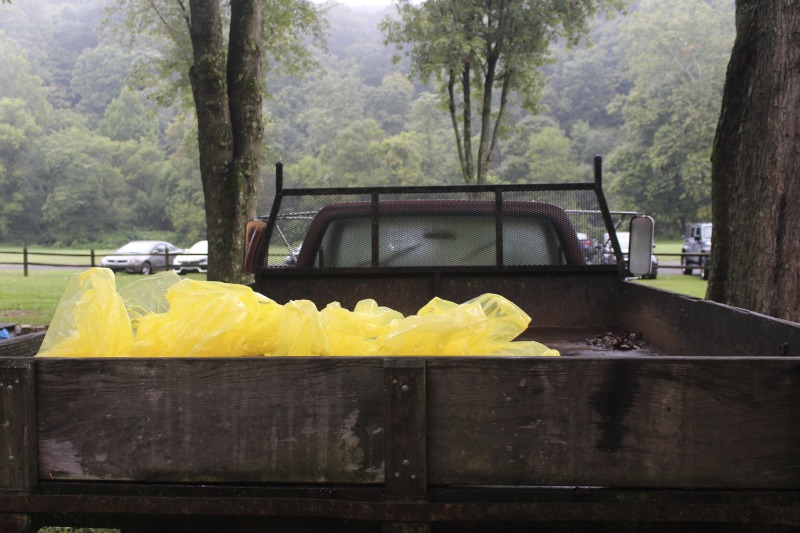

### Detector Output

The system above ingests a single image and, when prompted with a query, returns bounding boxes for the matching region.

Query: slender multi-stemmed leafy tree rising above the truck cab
[382,0,623,183]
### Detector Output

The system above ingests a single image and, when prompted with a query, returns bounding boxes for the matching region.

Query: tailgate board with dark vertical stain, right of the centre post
[427,357,800,489]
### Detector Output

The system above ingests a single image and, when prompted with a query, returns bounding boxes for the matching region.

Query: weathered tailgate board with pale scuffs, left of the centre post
[37,358,384,483]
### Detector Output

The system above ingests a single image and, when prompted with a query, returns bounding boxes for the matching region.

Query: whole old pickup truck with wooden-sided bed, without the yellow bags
[0,156,800,533]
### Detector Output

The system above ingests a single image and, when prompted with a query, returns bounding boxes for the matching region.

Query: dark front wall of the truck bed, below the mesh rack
[254,270,621,328]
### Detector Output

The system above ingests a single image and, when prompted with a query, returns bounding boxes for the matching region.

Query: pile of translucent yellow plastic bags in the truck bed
[38,268,559,357]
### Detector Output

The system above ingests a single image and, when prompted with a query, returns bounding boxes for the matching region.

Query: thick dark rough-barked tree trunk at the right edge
[708,0,800,322]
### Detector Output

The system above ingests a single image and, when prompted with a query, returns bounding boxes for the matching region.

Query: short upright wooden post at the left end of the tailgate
[0,357,37,491]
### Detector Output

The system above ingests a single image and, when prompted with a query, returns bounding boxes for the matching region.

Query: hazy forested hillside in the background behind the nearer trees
[0,0,734,246]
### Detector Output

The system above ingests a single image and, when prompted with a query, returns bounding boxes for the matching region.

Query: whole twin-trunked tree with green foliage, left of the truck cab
[108,0,319,281]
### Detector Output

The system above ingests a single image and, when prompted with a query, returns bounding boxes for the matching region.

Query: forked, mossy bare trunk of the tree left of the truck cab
[189,0,263,282]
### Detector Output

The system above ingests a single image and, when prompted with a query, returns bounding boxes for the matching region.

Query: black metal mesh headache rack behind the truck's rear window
[245,157,634,276]
